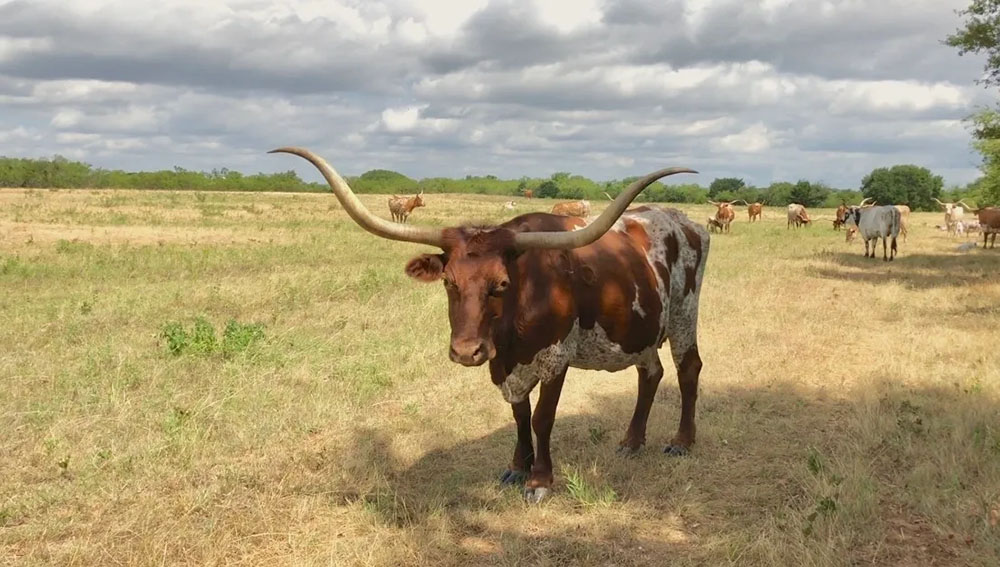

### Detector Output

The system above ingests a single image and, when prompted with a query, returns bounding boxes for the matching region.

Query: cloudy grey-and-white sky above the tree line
[0,0,995,187]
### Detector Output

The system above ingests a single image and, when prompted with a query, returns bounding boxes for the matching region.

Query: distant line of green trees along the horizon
[0,156,983,210]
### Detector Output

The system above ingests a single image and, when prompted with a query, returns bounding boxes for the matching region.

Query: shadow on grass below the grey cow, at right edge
[807,249,1000,289]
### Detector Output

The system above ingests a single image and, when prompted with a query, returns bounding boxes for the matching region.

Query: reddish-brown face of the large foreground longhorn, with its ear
[406,232,515,366]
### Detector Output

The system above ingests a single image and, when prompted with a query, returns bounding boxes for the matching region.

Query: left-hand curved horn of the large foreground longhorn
[267,147,444,248]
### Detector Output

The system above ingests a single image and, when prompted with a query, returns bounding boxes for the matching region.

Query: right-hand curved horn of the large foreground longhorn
[514,167,698,250]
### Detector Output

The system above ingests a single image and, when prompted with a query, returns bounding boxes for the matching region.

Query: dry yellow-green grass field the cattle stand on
[0,189,1000,566]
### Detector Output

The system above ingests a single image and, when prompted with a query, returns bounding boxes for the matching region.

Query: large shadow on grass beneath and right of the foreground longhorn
[322,381,1000,565]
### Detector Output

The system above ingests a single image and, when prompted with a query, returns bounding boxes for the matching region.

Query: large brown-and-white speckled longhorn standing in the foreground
[272,148,709,502]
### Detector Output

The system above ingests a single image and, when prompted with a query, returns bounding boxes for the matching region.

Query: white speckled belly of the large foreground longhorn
[500,323,659,403]
